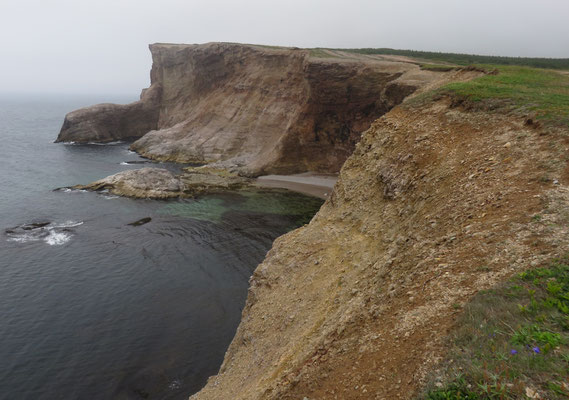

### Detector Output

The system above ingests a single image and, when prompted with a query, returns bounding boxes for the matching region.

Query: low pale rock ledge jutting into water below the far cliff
[72,168,250,199]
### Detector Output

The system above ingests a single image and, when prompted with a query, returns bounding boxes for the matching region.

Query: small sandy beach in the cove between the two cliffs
[254,172,338,200]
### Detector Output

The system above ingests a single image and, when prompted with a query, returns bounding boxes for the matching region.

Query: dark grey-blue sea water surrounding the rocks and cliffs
[0,96,321,400]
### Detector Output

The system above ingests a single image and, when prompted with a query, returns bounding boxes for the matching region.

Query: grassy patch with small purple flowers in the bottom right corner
[421,258,569,400]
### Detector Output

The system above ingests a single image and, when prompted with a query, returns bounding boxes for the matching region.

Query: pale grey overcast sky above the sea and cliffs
[0,0,569,95]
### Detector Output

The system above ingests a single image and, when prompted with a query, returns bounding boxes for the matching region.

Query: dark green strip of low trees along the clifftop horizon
[335,48,569,69]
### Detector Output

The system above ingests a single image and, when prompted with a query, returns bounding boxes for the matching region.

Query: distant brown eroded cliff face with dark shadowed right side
[57,43,440,175]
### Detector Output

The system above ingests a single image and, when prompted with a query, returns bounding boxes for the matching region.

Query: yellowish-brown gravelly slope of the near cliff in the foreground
[192,96,569,400]
